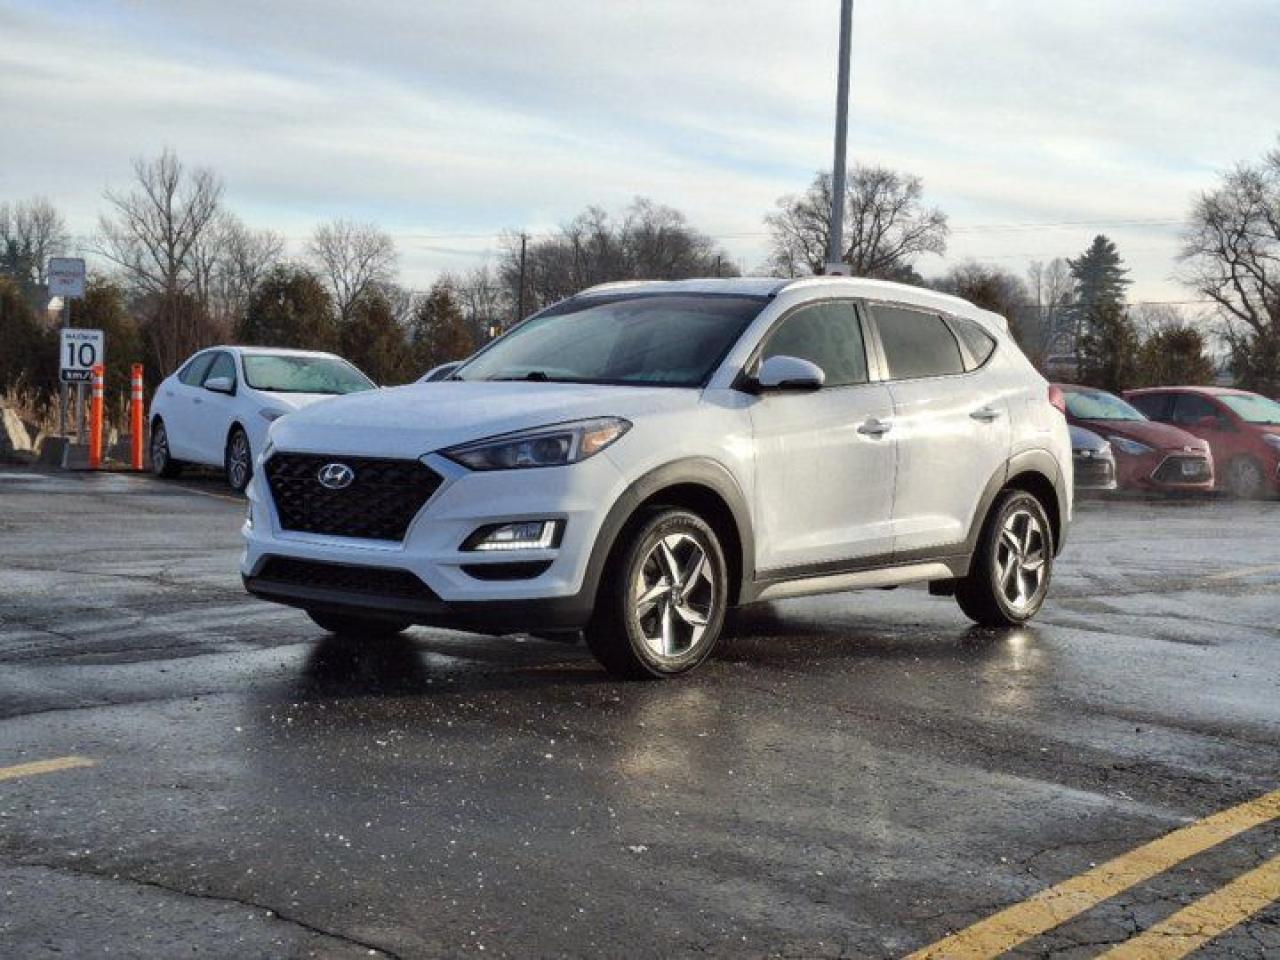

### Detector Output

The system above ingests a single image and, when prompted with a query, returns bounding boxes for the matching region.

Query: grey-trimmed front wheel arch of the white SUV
[582,458,755,605]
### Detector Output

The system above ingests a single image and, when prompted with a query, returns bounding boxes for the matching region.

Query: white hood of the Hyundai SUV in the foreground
[263,380,701,457]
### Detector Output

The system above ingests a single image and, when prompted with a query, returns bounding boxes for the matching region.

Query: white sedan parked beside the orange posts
[150,347,375,490]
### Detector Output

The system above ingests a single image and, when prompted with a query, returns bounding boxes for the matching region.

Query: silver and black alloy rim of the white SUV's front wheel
[632,534,716,659]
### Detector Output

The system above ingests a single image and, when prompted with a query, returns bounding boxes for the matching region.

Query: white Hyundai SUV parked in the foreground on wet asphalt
[241,278,1071,677]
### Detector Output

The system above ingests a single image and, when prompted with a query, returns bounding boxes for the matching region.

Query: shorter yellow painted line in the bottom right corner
[1102,856,1280,960]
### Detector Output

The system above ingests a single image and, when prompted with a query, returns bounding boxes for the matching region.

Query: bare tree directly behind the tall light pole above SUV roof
[764,166,948,282]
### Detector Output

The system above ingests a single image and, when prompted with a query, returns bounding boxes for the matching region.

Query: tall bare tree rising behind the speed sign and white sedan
[92,150,223,372]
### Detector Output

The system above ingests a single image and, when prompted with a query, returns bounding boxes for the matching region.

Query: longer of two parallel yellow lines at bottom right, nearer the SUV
[908,790,1280,960]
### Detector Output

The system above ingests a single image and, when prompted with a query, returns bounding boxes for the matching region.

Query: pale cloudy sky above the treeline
[0,0,1280,300]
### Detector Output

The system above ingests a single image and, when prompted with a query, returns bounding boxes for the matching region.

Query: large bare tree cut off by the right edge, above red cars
[1181,140,1280,392]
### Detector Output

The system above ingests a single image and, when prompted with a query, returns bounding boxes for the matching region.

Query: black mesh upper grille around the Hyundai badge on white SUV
[266,453,442,540]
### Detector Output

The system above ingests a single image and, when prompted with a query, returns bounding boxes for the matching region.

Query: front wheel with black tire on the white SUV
[584,508,728,680]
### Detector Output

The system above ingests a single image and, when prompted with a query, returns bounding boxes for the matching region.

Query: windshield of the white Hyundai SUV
[454,293,768,387]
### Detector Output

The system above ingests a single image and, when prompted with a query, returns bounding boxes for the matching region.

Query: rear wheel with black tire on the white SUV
[956,490,1053,627]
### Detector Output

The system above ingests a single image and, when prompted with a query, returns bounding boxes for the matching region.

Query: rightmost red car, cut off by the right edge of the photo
[1125,387,1280,497]
